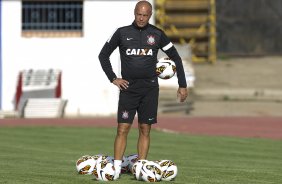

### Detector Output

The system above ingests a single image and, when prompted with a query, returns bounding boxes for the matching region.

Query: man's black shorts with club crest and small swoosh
[117,79,159,124]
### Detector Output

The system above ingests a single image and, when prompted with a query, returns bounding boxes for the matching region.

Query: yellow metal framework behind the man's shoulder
[155,0,216,64]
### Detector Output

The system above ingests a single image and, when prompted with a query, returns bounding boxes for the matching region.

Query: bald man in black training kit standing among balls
[99,1,188,179]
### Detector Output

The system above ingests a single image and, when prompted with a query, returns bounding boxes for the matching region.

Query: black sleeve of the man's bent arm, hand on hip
[99,29,119,82]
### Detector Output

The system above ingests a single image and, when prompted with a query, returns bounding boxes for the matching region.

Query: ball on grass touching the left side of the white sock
[93,156,115,181]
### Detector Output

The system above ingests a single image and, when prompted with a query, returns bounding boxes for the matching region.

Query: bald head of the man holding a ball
[134,1,152,28]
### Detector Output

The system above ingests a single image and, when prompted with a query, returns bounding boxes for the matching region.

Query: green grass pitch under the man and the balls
[0,127,282,184]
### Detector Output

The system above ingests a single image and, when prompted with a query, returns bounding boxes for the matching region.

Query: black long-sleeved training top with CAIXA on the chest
[99,22,187,87]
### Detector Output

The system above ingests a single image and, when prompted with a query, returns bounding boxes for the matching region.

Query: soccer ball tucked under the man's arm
[156,57,176,79]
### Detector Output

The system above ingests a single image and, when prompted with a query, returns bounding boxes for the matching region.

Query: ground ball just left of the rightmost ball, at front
[141,161,162,182]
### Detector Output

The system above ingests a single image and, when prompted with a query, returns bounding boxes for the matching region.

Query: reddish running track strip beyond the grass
[0,116,282,139]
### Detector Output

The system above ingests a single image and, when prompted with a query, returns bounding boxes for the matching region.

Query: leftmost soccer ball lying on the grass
[76,155,96,174]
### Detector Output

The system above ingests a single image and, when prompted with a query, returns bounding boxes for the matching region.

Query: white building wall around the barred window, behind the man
[1,0,152,115]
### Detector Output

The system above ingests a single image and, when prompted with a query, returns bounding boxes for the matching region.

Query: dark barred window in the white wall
[22,0,83,36]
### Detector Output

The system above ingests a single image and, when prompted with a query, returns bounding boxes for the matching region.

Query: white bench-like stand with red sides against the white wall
[14,69,67,118]
